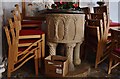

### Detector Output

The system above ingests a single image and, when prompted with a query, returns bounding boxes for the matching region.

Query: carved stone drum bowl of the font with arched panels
[47,14,84,43]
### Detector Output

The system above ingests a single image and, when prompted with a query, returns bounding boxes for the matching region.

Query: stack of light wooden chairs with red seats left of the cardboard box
[4,19,44,77]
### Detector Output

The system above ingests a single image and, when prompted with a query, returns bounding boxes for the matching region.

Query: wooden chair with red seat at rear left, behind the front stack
[13,4,42,29]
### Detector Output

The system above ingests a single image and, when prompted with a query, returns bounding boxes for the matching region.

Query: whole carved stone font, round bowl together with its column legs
[46,13,85,71]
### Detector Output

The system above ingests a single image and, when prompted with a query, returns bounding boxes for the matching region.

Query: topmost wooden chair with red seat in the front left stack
[13,10,45,60]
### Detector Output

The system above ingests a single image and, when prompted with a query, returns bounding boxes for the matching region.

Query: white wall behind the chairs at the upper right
[80,0,120,22]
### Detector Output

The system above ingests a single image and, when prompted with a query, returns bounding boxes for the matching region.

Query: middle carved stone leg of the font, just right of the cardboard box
[66,43,76,71]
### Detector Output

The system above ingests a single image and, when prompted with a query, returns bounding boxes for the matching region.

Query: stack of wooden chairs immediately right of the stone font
[85,6,110,68]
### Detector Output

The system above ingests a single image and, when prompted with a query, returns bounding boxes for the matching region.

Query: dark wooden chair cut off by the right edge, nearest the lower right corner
[108,29,120,74]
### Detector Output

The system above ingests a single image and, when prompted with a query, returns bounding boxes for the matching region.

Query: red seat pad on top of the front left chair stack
[20,30,44,36]
